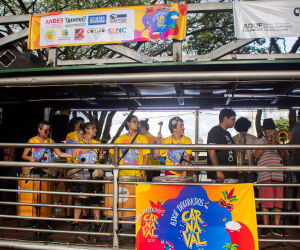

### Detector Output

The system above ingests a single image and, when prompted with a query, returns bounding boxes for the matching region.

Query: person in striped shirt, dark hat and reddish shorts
[254,118,288,238]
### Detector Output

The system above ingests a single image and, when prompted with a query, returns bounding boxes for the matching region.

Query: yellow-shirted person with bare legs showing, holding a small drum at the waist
[68,122,104,232]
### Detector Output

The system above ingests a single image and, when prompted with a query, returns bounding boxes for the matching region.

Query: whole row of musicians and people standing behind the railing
[0,109,300,238]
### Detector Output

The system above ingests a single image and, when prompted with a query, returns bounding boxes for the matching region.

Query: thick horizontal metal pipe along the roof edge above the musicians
[0,70,300,87]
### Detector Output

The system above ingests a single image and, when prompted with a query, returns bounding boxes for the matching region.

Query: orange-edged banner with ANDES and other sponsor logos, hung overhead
[28,4,187,49]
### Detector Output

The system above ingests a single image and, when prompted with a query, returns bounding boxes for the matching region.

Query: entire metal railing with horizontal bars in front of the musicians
[0,143,300,249]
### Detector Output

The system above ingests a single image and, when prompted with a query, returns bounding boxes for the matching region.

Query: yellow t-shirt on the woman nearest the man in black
[160,135,192,175]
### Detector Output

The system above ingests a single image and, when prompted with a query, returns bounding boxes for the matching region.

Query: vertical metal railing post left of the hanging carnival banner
[113,147,119,249]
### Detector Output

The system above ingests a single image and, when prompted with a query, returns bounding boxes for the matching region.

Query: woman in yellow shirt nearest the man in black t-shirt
[154,117,192,179]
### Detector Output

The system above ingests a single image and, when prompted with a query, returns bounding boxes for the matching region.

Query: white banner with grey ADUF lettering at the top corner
[233,0,300,39]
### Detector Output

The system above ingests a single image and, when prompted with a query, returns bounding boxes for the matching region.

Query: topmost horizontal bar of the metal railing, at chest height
[0,143,300,150]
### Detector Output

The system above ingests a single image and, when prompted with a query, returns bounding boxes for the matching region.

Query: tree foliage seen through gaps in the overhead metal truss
[0,0,300,60]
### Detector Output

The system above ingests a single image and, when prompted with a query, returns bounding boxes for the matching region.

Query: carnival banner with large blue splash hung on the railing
[136,184,258,250]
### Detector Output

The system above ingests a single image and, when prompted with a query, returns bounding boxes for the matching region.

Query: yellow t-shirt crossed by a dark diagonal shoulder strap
[109,134,150,176]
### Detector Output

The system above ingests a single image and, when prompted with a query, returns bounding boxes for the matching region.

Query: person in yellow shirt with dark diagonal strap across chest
[109,115,150,178]
